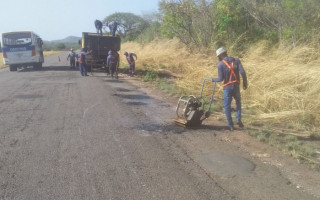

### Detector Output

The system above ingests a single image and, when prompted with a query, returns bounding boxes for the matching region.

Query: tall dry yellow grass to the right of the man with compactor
[243,43,320,126]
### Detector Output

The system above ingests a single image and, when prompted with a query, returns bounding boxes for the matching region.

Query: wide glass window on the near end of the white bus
[2,32,32,46]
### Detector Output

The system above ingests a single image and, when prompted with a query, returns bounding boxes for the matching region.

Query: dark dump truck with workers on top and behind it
[79,32,121,71]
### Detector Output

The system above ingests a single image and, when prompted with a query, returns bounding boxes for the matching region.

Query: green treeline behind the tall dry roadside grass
[104,0,320,51]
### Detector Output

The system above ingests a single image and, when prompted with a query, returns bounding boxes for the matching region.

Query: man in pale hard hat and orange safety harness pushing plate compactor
[212,47,248,131]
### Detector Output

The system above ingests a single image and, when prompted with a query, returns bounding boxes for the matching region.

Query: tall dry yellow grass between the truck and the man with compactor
[122,39,217,93]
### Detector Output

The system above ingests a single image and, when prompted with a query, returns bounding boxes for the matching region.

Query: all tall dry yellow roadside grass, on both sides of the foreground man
[122,39,320,126]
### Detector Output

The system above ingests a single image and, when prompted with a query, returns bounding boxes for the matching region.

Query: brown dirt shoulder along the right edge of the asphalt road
[124,76,320,198]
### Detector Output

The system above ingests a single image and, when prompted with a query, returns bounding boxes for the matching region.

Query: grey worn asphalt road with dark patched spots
[0,54,317,200]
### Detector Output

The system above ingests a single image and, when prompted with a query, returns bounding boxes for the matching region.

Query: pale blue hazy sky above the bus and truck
[0,0,159,41]
